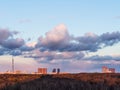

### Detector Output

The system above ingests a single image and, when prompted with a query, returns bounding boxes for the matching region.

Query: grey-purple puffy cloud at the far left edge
[0,29,24,49]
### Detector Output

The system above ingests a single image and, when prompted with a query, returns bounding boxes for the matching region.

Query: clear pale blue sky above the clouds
[0,0,120,36]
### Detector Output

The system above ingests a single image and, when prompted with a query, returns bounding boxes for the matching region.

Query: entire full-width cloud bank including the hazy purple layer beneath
[0,24,120,71]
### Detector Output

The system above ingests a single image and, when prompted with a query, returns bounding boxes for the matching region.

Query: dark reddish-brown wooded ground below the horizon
[0,73,120,90]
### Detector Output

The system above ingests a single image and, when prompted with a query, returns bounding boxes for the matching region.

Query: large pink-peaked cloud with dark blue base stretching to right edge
[36,24,120,52]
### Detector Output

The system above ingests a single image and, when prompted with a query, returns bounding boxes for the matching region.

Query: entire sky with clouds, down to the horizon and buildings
[0,0,120,73]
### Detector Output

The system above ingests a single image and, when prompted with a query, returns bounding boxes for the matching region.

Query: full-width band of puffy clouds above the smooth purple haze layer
[0,24,120,61]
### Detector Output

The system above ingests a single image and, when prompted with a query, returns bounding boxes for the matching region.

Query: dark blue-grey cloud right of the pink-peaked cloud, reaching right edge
[73,32,120,52]
